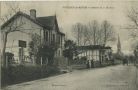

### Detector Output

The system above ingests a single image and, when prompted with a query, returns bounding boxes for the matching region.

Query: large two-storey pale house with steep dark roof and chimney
[1,9,65,64]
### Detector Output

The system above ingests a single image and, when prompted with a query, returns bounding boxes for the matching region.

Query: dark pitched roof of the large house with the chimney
[1,11,65,35]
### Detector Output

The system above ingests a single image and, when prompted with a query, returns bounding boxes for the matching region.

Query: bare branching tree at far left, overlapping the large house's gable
[1,2,25,66]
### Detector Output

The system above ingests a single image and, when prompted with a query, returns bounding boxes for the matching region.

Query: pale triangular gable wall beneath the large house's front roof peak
[2,15,43,32]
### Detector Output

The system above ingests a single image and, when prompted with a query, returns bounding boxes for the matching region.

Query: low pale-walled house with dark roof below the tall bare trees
[74,45,112,66]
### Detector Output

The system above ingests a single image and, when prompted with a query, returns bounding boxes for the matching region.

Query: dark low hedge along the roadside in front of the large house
[1,65,60,86]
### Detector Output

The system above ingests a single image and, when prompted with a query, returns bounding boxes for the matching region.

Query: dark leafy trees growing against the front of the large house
[29,33,58,65]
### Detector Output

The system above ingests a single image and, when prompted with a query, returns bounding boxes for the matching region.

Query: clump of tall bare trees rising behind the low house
[73,20,116,46]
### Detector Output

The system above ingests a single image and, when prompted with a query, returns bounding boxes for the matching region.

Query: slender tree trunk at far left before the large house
[1,32,8,67]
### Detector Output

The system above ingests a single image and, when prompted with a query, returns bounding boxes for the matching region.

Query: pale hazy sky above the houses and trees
[0,0,138,54]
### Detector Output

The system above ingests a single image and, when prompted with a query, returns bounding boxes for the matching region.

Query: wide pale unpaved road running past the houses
[4,65,138,90]
